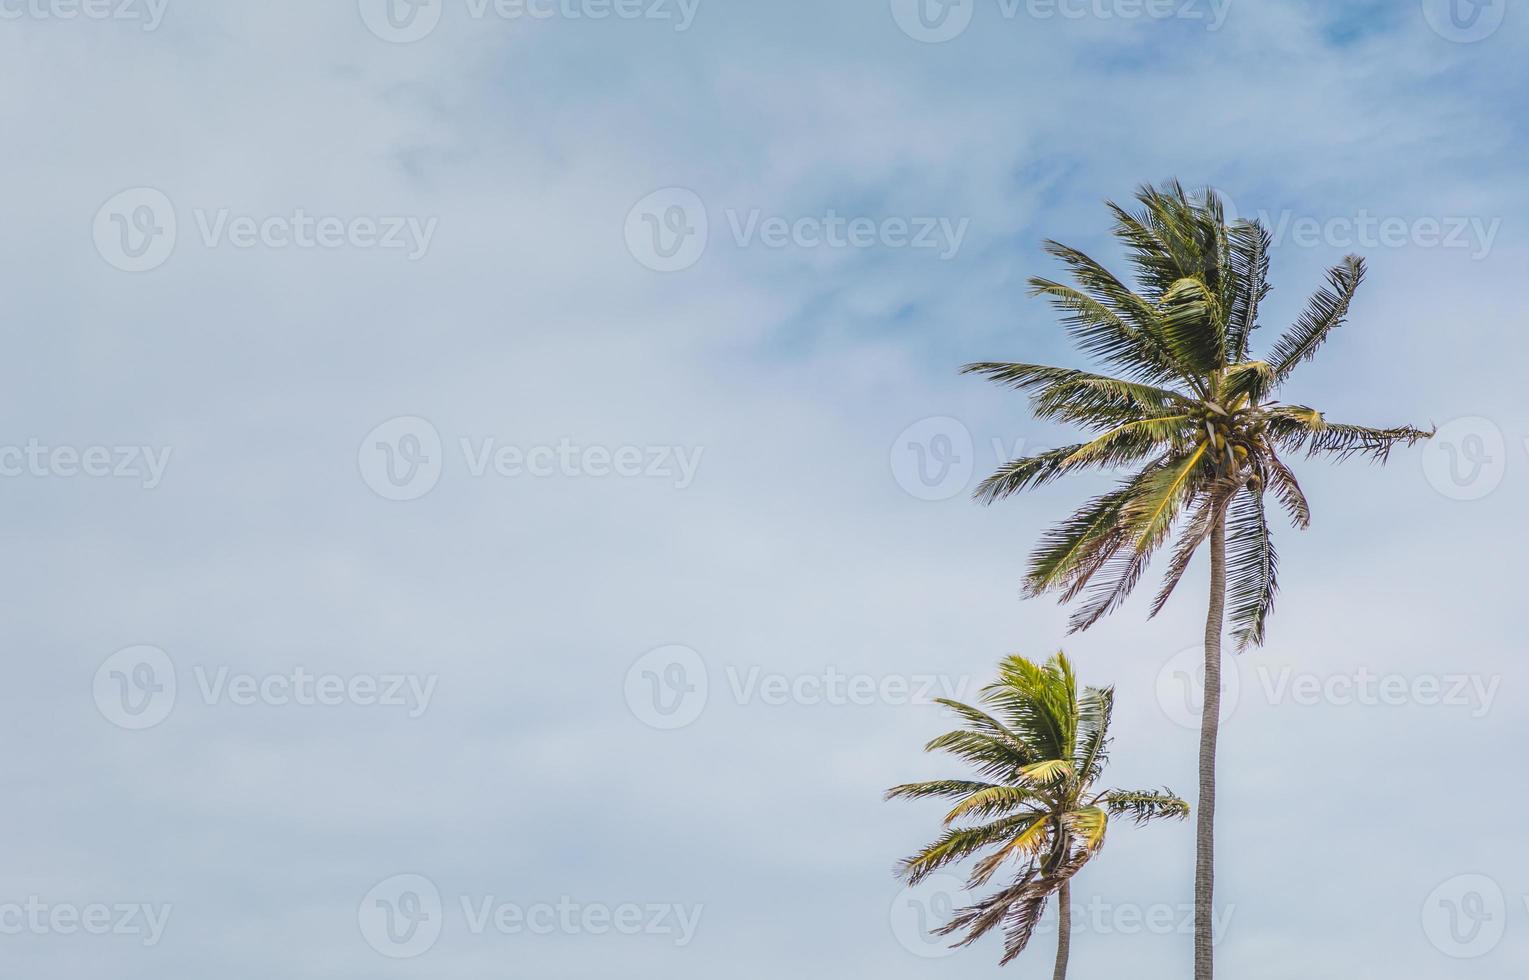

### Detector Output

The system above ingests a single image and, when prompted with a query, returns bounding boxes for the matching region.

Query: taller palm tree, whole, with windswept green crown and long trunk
[965,182,1433,980]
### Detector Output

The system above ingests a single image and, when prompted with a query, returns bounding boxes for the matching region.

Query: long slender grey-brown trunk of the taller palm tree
[1194,517,1226,980]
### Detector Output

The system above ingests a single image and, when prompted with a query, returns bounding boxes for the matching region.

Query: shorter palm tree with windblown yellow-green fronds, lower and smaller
[887,653,1190,980]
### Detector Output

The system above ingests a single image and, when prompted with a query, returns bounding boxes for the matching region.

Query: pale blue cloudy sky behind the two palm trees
[0,0,1529,980]
